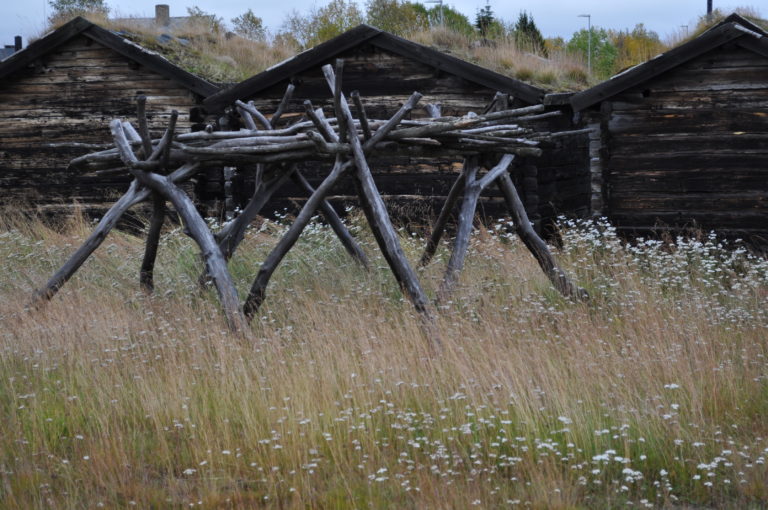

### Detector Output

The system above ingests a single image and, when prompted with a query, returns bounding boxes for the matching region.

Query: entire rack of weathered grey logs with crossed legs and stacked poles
[35,60,587,331]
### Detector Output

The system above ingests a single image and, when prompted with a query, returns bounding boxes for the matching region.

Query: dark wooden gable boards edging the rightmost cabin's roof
[571,14,768,111]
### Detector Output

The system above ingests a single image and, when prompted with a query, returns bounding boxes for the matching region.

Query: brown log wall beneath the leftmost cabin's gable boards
[0,36,199,210]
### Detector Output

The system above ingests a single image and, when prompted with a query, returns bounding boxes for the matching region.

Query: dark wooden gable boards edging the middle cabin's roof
[205,25,545,108]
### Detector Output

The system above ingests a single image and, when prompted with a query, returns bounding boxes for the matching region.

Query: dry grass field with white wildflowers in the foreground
[0,213,768,509]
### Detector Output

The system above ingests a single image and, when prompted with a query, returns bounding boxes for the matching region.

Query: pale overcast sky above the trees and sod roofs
[0,0,766,46]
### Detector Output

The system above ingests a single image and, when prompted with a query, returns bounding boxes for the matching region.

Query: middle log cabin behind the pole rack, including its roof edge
[205,25,589,229]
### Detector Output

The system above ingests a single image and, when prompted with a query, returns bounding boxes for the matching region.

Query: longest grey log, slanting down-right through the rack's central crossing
[323,65,431,316]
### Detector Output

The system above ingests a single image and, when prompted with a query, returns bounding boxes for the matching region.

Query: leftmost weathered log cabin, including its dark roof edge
[0,18,219,214]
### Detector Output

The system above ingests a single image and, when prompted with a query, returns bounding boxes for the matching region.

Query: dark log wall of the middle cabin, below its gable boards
[207,44,588,227]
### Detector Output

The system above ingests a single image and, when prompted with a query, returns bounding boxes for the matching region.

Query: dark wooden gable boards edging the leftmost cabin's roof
[0,16,219,97]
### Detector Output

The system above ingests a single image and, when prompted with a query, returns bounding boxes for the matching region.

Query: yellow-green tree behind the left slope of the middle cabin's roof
[281,0,363,48]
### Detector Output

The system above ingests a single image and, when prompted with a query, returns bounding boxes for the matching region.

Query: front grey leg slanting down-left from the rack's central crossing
[243,156,351,321]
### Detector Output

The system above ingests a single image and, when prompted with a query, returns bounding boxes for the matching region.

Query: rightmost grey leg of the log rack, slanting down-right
[496,173,589,300]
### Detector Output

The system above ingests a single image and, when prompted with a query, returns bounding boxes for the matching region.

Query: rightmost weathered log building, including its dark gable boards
[571,15,768,239]
